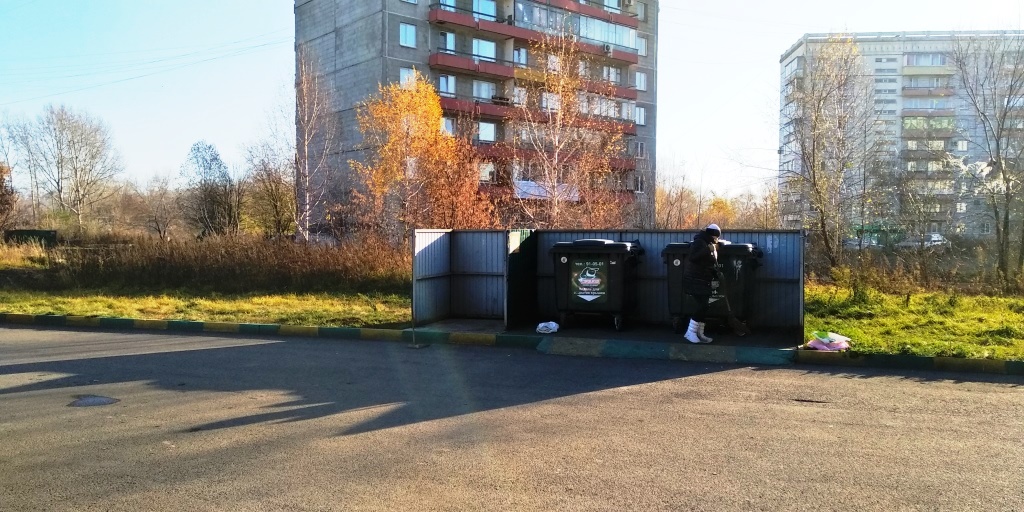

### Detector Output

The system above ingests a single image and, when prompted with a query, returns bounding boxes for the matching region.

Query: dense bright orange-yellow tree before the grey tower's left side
[350,74,494,242]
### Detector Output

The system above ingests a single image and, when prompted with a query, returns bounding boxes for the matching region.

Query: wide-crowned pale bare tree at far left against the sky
[7,105,122,229]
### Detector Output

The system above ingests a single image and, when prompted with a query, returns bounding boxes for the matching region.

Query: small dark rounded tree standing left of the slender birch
[180,140,243,237]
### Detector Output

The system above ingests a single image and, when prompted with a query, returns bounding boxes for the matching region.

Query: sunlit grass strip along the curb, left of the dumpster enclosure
[0,290,411,328]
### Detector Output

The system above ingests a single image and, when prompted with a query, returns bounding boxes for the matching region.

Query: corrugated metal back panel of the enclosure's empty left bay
[452,231,508,318]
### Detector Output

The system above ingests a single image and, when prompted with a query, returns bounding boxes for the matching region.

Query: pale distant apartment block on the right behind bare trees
[779,32,1020,237]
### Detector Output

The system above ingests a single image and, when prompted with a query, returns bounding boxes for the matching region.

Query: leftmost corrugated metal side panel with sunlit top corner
[413,229,454,325]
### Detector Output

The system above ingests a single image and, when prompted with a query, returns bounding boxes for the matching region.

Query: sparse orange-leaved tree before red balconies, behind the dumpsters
[499,34,635,228]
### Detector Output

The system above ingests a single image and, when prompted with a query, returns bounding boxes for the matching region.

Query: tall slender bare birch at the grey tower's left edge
[294,47,339,240]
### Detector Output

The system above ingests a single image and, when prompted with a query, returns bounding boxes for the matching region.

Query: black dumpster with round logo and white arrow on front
[550,239,644,331]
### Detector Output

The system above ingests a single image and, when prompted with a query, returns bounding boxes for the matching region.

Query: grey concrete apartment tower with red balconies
[295,0,658,226]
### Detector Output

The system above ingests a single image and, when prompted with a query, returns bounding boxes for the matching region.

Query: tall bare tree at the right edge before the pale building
[950,32,1024,285]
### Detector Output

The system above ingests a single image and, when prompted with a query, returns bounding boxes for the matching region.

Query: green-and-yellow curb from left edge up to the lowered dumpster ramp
[0,313,541,349]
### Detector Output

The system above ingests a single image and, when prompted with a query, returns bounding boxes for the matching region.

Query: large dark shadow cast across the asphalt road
[0,331,735,435]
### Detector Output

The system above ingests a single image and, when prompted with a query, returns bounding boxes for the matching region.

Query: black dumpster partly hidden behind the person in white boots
[662,242,764,333]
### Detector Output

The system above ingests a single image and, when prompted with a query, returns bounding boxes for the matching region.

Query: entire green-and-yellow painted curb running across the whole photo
[0,313,1024,376]
